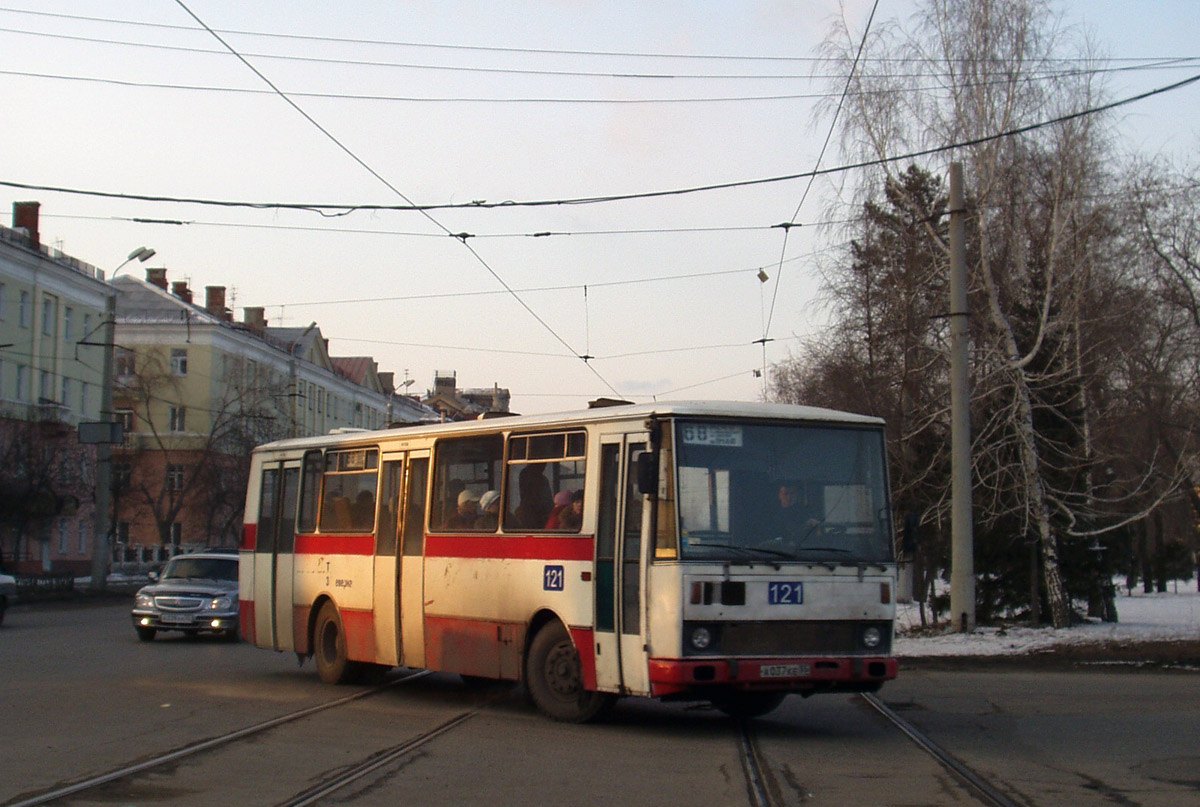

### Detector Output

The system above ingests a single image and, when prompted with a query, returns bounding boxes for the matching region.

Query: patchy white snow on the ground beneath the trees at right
[894,579,1200,657]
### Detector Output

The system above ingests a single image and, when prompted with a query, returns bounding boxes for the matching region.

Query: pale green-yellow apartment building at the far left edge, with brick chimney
[0,202,114,574]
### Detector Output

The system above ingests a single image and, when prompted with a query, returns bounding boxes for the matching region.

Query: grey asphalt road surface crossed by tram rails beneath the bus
[0,600,1200,807]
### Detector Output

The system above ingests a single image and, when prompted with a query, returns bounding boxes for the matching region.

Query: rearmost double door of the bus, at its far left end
[253,460,300,650]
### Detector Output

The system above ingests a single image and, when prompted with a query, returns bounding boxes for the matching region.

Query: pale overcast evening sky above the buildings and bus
[0,0,1200,413]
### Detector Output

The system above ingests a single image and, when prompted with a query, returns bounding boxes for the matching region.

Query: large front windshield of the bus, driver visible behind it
[676,420,893,563]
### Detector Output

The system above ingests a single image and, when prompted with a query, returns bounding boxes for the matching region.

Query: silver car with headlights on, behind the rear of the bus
[132,552,238,641]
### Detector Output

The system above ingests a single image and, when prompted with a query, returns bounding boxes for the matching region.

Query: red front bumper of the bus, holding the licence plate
[649,656,899,698]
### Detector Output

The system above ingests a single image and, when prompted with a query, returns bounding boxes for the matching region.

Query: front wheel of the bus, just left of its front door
[524,622,612,723]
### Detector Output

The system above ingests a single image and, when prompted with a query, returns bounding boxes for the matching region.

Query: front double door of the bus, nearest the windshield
[595,432,649,692]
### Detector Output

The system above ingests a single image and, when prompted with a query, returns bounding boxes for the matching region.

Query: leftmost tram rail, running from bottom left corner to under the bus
[0,670,431,807]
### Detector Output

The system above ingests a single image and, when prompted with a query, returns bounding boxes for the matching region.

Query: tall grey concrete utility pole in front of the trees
[950,162,974,633]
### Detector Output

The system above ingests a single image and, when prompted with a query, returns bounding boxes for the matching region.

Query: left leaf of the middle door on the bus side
[372,453,404,666]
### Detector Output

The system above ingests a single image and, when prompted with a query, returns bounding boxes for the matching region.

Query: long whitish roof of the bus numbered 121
[259,401,883,450]
